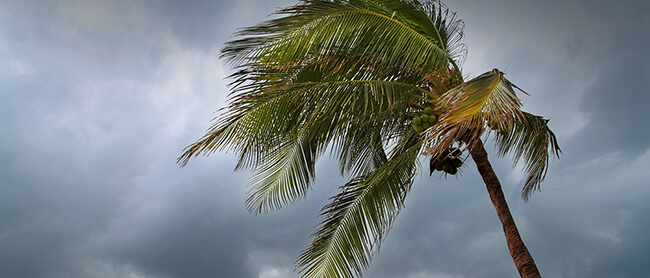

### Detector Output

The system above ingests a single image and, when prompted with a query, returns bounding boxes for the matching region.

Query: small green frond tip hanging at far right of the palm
[495,112,562,200]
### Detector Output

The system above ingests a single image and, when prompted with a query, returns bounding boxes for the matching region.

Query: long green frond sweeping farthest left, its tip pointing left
[179,77,426,163]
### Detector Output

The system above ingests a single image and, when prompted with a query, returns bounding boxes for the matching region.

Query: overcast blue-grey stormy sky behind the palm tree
[0,0,650,278]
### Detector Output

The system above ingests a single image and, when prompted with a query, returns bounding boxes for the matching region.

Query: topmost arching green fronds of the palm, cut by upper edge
[223,1,458,76]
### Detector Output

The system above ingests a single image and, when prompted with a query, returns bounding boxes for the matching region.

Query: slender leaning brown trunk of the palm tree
[469,140,541,278]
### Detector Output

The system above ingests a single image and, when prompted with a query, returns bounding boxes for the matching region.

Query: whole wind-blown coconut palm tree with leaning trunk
[178,0,560,277]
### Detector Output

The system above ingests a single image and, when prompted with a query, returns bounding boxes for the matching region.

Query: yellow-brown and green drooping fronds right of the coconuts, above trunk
[420,69,560,200]
